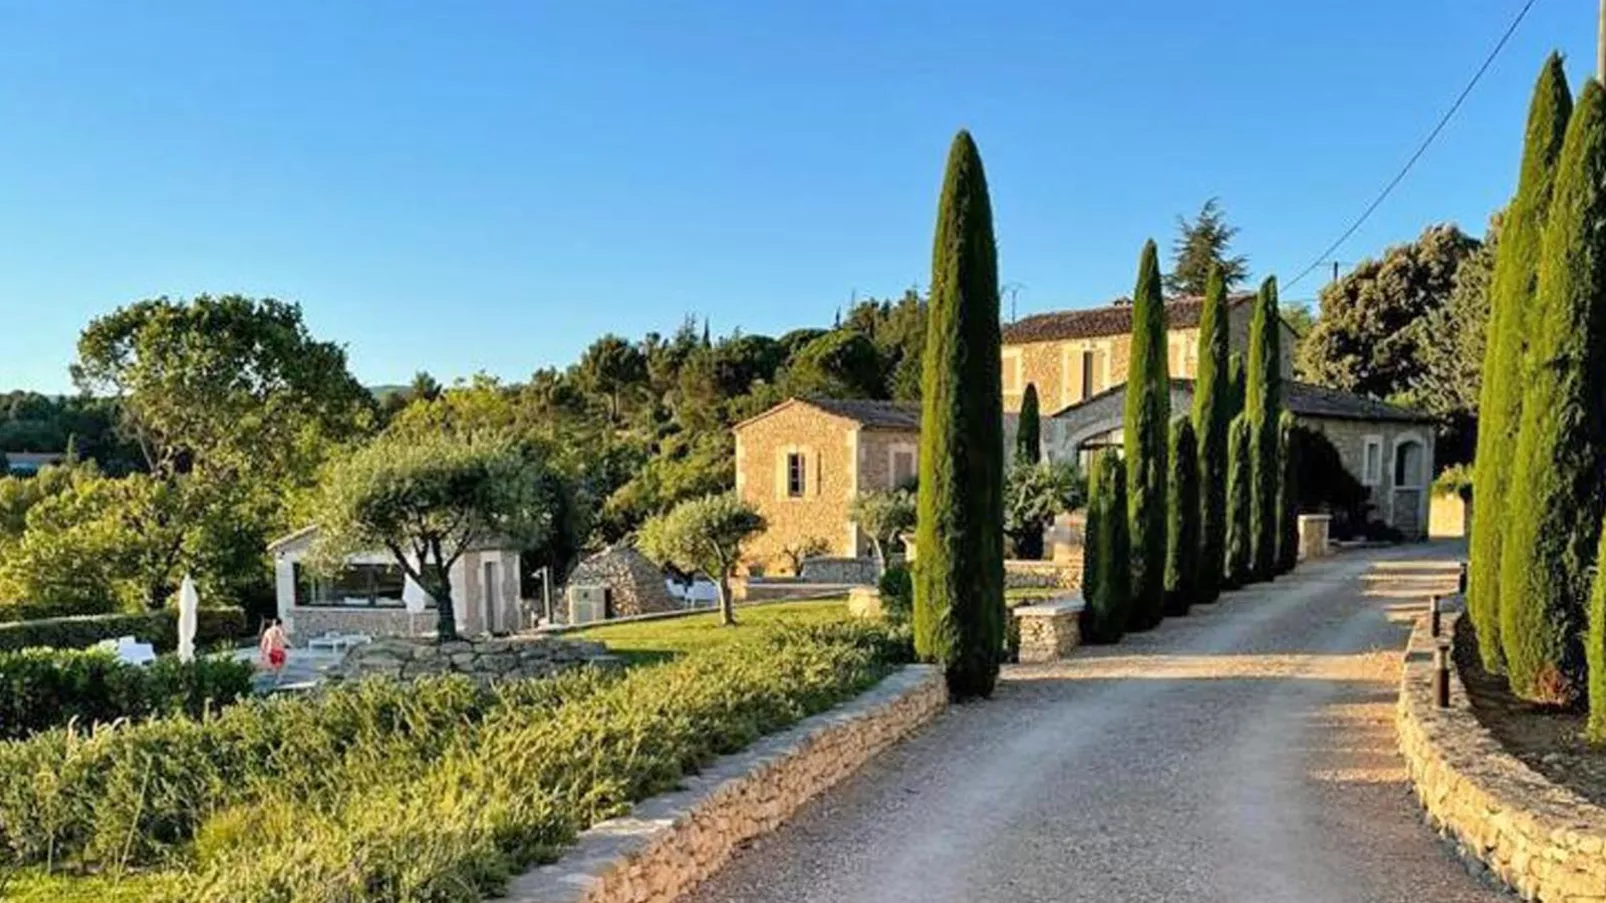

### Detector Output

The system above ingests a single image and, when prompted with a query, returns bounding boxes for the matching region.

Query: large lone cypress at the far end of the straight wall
[914,130,1005,699]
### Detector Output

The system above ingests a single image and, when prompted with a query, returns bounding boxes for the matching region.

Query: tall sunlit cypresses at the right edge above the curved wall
[1468,55,1606,741]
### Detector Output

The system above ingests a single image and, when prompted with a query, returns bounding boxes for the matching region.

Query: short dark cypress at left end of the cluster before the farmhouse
[1079,452,1132,643]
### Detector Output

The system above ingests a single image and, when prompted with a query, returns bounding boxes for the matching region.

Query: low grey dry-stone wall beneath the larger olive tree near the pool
[332,635,617,683]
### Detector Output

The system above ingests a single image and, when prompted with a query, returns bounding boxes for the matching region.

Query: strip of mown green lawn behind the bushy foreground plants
[570,598,848,664]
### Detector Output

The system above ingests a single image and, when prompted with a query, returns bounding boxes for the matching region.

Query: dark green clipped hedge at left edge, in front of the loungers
[0,649,255,741]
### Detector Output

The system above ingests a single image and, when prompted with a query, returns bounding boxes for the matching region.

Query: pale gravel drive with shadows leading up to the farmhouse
[689,546,1508,903]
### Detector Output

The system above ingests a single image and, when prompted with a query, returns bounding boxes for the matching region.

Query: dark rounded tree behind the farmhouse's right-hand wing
[1294,225,1478,398]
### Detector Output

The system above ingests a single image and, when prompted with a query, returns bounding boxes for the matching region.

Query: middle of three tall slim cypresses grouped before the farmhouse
[1193,267,1233,604]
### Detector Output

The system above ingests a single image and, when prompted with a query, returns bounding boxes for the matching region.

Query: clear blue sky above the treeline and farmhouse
[0,0,1595,392]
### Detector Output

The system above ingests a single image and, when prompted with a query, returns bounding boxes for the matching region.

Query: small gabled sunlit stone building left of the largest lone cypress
[734,398,920,570]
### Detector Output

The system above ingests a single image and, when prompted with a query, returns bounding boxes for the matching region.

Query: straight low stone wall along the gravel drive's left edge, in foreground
[496,665,948,903]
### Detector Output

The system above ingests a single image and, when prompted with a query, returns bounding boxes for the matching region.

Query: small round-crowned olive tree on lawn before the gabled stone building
[641,493,764,627]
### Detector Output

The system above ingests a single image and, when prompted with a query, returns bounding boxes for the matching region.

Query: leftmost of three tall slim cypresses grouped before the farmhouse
[1121,239,1171,630]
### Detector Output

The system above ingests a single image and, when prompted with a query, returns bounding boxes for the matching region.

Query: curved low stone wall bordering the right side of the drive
[1397,614,1606,903]
